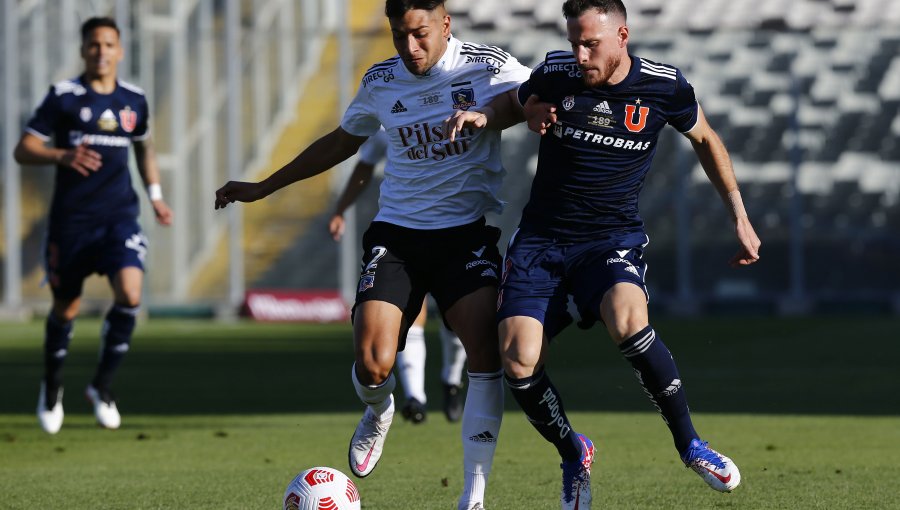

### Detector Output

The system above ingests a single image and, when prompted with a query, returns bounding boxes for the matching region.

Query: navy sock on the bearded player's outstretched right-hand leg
[619,326,699,454]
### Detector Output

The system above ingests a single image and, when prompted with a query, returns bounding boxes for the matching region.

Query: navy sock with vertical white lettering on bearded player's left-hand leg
[506,368,581,462]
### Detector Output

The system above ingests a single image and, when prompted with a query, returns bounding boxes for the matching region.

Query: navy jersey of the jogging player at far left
[26,78,149,227]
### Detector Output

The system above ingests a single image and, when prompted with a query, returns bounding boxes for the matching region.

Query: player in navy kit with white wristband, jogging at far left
[15,18,172,434]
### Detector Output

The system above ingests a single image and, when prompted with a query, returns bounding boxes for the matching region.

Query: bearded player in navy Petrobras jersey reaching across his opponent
[450,0,760,509]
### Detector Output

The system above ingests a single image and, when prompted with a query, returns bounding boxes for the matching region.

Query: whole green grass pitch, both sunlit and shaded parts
[0,317,900,510]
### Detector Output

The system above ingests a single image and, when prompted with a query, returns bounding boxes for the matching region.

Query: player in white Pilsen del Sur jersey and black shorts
[216,0,530,510]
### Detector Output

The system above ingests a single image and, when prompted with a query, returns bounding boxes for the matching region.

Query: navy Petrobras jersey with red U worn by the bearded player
[519,51,698,241]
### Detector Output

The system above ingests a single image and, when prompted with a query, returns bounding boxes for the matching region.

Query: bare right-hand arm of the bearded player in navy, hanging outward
[685,105,762,267]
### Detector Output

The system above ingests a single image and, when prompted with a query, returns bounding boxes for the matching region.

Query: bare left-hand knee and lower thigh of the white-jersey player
[353,300,404,384]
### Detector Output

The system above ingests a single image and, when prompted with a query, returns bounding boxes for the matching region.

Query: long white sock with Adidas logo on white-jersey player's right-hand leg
[459,371,503,510]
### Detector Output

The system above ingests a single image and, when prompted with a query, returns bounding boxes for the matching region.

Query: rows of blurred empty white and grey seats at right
[448,0,900,299]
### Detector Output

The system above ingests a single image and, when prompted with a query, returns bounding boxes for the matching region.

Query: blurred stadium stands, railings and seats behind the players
[0,0,900,316]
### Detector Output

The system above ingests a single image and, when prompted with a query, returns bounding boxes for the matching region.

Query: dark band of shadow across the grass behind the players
[0,317,900,416]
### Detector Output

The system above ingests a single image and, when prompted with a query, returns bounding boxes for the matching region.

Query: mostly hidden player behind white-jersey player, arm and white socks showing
[328,129,466,423]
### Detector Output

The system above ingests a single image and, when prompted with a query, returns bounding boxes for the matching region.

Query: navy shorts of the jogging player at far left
[44,218,147,299]
